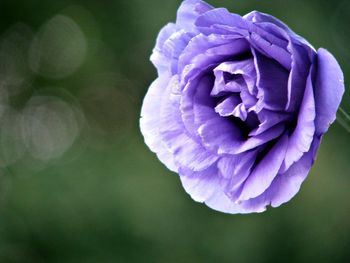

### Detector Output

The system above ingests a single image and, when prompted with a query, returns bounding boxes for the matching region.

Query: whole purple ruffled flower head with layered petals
[140,0,344,213]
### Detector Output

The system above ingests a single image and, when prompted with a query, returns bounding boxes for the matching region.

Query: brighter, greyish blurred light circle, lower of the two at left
[21,96,80,161]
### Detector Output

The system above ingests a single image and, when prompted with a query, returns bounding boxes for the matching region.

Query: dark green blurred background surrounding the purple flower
[0,0,350,263]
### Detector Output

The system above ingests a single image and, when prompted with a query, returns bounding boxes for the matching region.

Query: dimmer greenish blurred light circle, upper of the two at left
[29,15,87,79]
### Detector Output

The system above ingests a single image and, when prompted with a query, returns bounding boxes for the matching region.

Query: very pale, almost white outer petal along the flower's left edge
[140,75,177,172]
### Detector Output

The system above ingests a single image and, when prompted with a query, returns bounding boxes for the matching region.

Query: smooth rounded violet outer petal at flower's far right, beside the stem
[315,48,344,135]
